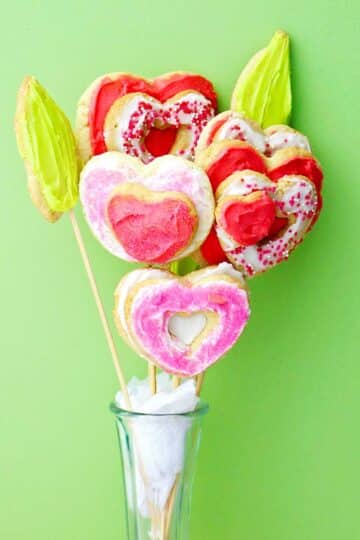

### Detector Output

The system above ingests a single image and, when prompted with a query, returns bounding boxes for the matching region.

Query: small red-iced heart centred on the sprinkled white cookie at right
[220,192,275,246]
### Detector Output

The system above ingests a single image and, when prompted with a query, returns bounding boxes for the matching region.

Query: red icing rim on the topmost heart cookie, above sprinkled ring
[89,73,217,155]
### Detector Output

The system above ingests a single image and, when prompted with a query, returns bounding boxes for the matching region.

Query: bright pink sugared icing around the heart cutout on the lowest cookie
[132,280,250,376]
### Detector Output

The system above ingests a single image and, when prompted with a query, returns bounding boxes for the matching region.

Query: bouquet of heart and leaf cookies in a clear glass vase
[15,31,322,540]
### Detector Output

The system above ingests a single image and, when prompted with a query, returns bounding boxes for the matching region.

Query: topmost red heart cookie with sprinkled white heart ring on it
[76,72,217,163]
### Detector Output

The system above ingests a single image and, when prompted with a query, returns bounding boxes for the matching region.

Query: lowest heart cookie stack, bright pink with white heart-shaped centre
[114,263,250,377]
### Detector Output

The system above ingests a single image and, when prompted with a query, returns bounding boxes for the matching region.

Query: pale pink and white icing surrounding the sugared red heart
[80,152,214,262]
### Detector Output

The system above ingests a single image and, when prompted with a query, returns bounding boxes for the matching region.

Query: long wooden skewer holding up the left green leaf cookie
[69,210,131,410]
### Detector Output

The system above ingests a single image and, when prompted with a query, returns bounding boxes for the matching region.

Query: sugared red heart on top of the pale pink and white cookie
[107,194,196,263]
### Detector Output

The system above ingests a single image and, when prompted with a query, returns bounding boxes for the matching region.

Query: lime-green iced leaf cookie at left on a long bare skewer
[15,77,79,212]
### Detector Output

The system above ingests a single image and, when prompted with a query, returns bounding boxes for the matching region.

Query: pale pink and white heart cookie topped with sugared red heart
[80,152,214,264]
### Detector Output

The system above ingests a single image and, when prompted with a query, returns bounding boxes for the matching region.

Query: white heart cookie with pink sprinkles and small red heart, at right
[216,170,318,276]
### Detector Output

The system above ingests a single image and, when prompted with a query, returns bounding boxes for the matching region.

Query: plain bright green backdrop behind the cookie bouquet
[0,0,360,540]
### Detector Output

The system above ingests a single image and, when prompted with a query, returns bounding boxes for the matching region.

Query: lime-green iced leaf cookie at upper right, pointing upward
[231,30,291,128]
